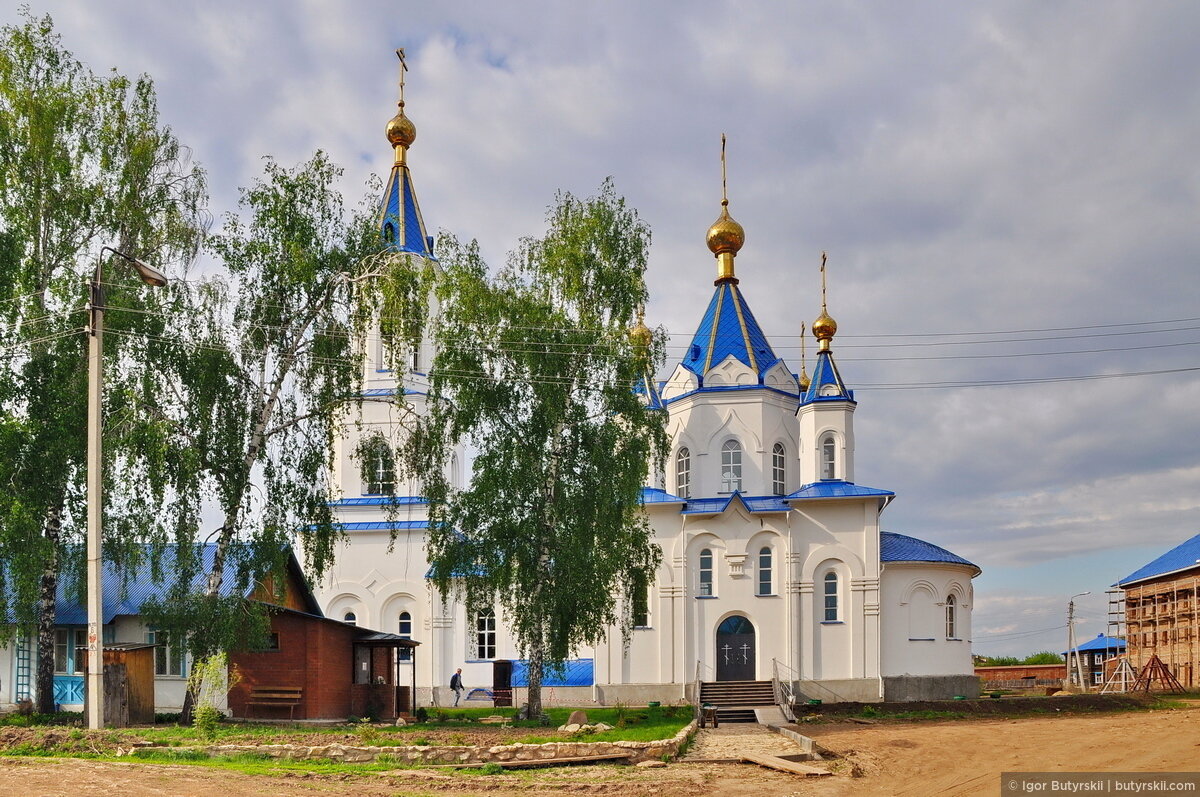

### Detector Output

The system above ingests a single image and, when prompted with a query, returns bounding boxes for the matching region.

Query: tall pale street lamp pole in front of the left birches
[88,246,167,730]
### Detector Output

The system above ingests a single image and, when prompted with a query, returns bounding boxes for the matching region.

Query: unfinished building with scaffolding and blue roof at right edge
[1114,534,1200,689]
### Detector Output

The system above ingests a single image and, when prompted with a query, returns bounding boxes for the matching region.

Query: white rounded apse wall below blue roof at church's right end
[881,563,974,676]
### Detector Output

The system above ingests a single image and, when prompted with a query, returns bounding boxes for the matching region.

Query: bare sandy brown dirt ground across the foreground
[0,708,1200,797]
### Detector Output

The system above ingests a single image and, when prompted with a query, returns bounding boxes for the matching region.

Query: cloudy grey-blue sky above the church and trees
[11,0,1200,654]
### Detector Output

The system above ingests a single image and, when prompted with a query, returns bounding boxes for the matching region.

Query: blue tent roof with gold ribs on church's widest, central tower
[683,280,779,383]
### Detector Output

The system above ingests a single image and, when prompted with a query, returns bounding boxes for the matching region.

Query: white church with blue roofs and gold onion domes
[317,69,980,706]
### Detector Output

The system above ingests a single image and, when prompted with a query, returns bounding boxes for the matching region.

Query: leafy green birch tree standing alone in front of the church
[407,181,666,714]
